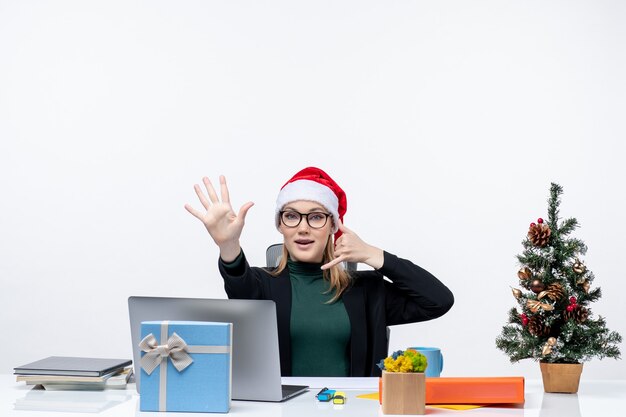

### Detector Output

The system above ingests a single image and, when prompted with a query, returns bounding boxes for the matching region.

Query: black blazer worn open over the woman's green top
[219,252,454,377]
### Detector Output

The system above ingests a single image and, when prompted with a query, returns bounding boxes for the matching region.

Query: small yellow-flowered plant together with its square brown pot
[378,349,428,414]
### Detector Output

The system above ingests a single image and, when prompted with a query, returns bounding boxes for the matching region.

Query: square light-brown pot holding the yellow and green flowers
[382,371,426,414]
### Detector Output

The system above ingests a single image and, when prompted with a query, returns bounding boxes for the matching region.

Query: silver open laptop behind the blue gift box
[128,296,308,402]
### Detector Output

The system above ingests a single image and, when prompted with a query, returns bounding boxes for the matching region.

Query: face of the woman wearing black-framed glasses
[278,200,333,263]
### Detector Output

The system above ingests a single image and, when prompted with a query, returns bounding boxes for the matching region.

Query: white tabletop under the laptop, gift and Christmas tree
[0,375,626,417]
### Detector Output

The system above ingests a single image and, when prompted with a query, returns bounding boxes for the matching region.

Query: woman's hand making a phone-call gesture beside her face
[322,219,384,269]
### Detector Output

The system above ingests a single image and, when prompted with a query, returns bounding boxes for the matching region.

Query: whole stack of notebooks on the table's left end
[13,356,132,390]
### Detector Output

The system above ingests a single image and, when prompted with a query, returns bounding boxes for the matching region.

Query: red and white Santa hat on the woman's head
[276,167,348,239]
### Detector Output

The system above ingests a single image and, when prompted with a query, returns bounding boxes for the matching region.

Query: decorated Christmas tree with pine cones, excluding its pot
[496,183,622,363]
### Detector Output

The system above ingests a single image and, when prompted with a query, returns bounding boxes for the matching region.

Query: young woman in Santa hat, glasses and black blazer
[185,167,454,376]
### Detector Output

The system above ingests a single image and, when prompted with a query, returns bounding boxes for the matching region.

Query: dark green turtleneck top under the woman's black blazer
[288,259,350,376]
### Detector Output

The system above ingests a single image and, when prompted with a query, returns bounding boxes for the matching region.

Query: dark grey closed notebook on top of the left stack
[13,356,133,376]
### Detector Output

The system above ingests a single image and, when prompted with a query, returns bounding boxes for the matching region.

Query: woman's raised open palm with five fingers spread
[185,175,254,261]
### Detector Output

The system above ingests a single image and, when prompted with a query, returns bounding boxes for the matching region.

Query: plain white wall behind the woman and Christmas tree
[0,0,626,379]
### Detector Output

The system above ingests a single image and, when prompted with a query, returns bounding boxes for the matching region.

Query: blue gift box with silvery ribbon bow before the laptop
[139,321,232,413]
